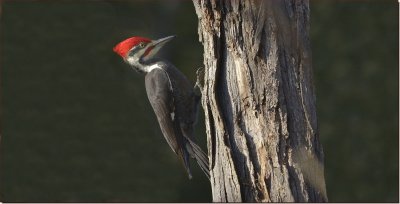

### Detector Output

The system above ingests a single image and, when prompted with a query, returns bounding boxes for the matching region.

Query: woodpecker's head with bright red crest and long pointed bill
[113,36,175,72]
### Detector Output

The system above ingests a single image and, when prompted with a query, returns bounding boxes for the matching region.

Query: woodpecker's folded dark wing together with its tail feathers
[146,68,210,178]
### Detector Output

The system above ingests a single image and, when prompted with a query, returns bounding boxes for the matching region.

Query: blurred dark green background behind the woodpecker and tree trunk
[0,0,399,202]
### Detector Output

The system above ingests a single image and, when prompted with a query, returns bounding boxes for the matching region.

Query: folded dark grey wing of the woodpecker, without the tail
[146,68,182,154]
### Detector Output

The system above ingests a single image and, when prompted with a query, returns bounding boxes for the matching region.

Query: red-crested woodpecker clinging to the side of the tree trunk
[113,36,210,179]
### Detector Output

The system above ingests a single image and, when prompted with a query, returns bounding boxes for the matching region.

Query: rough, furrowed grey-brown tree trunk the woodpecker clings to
[193,0,327,202]
